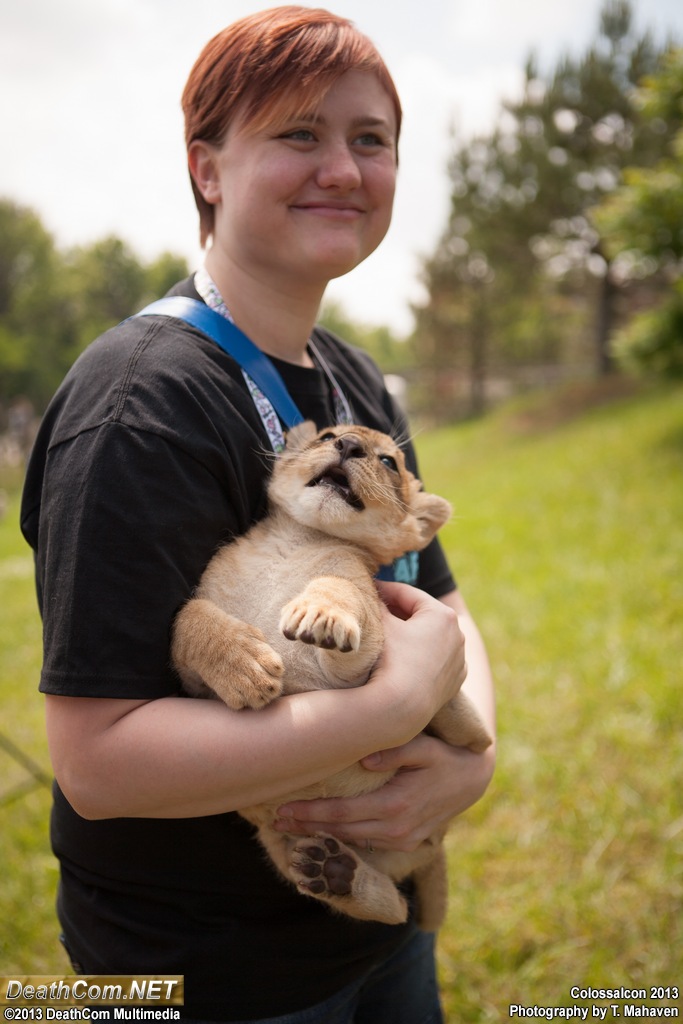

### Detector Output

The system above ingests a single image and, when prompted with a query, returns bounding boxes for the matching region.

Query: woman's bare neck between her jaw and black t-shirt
[206,250,323,367]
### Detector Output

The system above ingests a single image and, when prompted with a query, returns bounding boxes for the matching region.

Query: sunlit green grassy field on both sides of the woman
[0,388,683,1024]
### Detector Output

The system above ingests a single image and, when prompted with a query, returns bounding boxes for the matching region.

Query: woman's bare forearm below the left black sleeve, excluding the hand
[46,691,411,818]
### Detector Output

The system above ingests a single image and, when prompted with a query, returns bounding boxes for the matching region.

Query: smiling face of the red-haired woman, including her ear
[194,71,396,290]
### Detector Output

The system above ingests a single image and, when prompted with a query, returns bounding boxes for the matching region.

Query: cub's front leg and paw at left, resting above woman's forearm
[176,598,285,711]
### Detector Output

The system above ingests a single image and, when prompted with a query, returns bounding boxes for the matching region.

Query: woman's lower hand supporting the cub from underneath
[275,733,495,852]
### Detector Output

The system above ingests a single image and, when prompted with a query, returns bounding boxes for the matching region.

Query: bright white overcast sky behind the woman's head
[0,0,683,332]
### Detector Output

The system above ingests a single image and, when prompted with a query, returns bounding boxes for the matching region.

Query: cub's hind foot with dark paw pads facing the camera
[259,828,408,925]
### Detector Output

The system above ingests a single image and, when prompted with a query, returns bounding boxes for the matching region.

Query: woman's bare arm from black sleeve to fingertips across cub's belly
[47,588,464,818]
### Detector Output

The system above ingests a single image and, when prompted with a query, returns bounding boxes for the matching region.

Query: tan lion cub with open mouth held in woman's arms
[172,423,490,931]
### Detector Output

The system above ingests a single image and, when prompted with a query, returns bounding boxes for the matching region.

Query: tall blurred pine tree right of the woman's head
[416,0,669,412]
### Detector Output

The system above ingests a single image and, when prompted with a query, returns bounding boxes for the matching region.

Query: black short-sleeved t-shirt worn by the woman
[22,281,454,1020]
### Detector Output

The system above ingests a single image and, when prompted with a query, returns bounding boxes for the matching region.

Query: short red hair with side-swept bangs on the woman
[182,6,401,245]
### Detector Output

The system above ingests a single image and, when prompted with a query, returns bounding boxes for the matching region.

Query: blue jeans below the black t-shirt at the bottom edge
[182,932,443,1024]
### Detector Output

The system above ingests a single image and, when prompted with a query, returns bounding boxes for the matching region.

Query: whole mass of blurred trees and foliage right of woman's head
[414,0,683,421]
